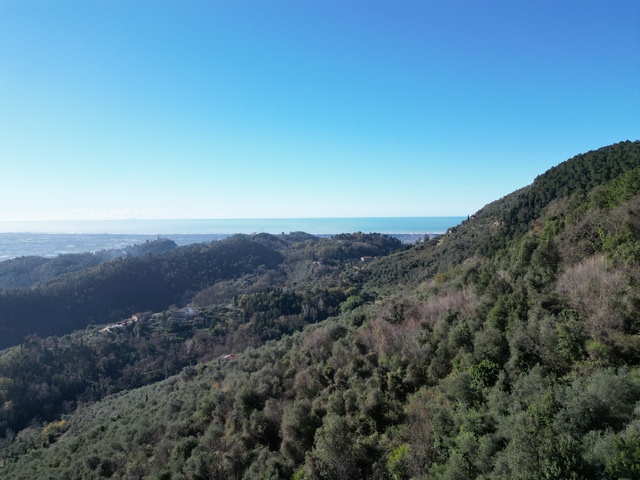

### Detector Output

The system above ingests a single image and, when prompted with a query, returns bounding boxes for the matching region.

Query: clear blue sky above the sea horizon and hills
[0,0,640,221]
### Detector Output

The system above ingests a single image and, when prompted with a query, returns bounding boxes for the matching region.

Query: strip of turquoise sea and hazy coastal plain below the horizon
[0,217,466,261]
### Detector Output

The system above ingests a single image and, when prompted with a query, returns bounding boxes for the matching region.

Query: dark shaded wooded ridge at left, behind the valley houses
[0,236,283,348]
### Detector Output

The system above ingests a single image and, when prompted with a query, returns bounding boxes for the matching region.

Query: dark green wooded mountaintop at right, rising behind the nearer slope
[368,141,640,286]
